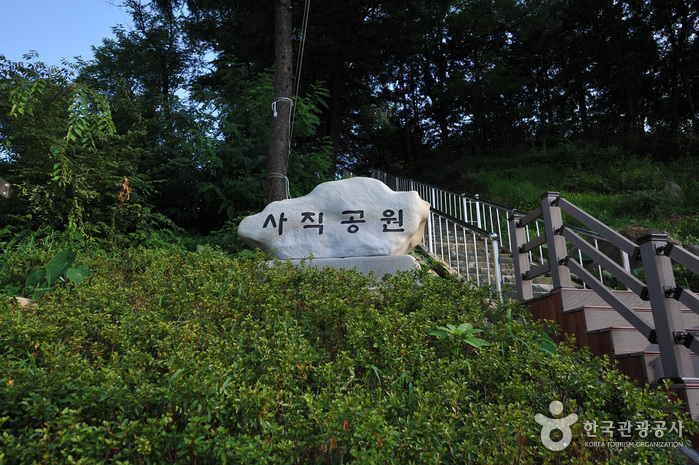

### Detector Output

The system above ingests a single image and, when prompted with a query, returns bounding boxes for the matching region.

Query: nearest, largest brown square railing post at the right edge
[638,234,695,378]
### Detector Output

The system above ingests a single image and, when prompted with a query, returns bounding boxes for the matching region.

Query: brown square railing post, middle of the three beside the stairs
[541,192,573,289]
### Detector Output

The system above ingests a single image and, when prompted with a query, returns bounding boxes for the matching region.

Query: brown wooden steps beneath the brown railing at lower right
[527,288,699,420]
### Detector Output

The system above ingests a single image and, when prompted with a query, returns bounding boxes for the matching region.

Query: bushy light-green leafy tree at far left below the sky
[0,56,154,238]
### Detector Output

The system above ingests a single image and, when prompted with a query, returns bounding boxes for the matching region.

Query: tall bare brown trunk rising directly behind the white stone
[267,0,294,203]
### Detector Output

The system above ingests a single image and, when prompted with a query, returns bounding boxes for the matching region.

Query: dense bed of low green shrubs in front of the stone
[0,247,697,464]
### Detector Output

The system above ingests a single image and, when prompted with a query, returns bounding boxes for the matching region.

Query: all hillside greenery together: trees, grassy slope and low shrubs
[0,0,699,465]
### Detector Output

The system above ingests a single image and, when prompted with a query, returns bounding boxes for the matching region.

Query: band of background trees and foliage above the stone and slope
[0,0,699,236]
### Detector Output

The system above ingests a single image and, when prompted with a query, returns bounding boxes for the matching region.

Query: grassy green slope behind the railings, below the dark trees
[405,142,699,244]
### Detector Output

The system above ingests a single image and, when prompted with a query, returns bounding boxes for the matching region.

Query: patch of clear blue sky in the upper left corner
[0,0,130,65]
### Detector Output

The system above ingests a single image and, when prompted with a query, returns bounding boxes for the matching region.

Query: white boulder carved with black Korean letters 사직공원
[238,177,430,259]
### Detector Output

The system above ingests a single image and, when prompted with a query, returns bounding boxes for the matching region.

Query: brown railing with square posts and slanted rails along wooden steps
[509,192,699,379]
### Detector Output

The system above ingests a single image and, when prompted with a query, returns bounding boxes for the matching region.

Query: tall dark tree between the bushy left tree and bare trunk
[81,0,225,232]
